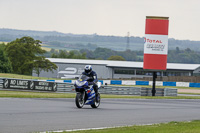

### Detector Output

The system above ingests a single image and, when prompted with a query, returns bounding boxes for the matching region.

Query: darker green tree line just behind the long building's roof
[47,47,200,64]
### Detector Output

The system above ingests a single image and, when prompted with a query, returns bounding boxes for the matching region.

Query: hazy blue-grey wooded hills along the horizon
[0,28,200,51]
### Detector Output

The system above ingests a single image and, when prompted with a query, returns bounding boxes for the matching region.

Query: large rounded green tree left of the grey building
[5,37,57,75]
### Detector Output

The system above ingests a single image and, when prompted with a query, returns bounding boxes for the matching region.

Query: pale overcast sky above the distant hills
[0,0,200,41]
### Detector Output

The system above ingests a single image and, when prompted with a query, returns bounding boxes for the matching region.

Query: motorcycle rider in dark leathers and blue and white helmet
[82,65,98,95]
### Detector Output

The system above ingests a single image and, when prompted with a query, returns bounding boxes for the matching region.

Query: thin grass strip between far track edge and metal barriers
[0,90,200,99]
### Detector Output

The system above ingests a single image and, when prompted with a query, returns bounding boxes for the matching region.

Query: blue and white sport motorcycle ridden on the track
[74,75,101,108]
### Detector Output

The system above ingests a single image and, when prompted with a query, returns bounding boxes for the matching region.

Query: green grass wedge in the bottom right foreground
[60,120,200,133]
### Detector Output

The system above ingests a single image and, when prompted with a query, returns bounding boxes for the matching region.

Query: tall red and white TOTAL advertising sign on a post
[143,16,169,70]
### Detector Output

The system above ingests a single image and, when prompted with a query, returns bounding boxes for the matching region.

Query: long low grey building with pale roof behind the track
[33,58,200,79]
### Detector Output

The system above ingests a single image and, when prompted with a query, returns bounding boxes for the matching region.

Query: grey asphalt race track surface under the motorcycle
[0,98,200,133]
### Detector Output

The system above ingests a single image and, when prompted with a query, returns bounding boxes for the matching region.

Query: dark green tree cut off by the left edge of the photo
[0,43,12,73]
